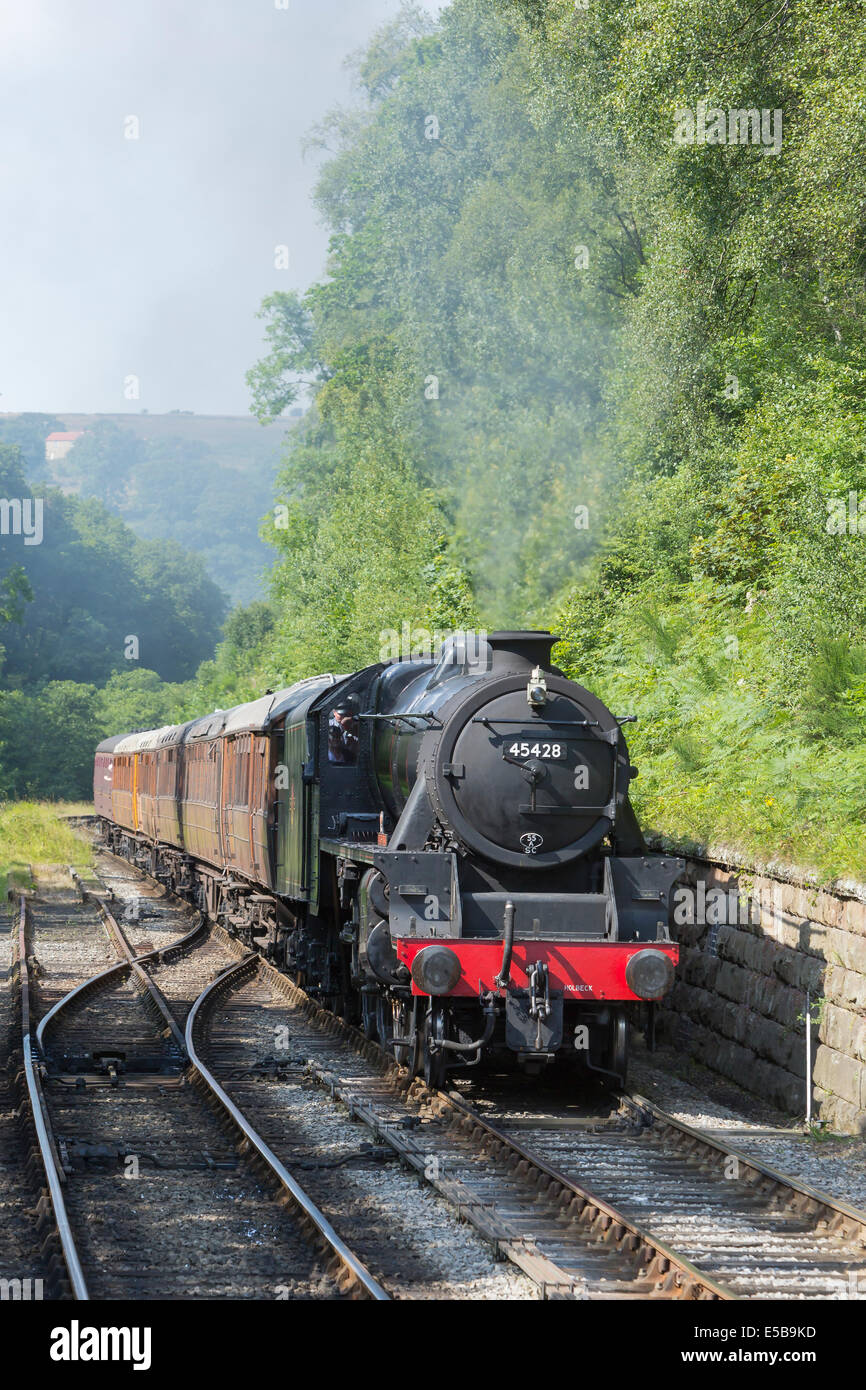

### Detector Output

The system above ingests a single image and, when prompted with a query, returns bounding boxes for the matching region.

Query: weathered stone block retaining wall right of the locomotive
[657,842,866,1134]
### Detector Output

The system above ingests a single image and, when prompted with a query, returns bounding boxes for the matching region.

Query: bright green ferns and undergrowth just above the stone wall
[560,591,866,884]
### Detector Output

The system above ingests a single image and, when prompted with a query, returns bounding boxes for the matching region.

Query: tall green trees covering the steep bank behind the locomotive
[233,0,866,873]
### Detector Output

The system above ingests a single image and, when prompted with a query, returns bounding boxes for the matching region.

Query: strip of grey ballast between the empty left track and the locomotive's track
[188,962,537,1301]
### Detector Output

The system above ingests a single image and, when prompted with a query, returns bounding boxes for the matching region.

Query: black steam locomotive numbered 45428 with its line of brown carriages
[93,631,684,1086]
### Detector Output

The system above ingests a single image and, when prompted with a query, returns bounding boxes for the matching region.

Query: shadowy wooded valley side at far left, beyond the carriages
[0,427,225,799]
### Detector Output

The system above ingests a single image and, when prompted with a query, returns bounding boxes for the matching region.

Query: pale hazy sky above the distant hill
[0,0,443,416]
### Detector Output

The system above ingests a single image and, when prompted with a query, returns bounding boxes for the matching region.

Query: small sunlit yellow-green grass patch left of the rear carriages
[0,801,93,897]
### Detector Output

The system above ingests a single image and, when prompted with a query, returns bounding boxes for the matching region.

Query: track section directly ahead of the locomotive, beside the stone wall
[461,1090,866,1300]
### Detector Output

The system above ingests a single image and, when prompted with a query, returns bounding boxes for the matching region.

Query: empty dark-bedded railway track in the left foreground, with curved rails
[12,899,386,1300]
